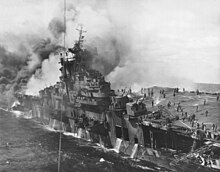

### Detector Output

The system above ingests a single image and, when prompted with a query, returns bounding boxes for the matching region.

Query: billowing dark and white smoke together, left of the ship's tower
[0,1,65,101]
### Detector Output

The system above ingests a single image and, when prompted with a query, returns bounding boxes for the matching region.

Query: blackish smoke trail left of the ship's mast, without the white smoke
[0,18,65,102]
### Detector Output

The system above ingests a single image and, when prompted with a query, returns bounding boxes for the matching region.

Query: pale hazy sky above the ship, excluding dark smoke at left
[0,0,220,92]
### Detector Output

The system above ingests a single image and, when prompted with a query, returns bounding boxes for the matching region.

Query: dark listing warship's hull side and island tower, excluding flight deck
[12,28,220,170]
